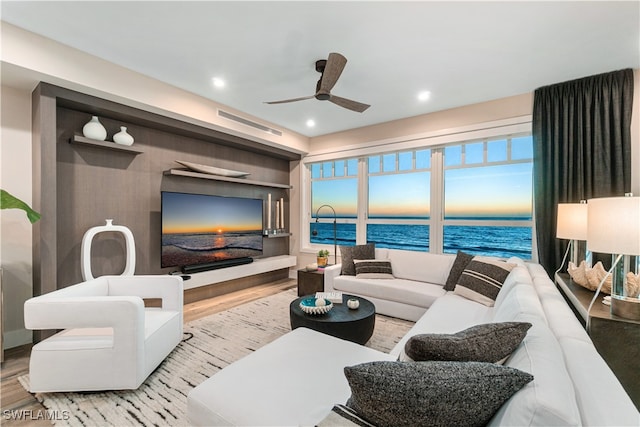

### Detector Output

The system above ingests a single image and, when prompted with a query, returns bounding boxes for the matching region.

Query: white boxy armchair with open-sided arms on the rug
[24,275,183,392]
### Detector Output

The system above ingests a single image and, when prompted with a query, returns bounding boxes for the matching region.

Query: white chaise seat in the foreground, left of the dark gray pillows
[187,328,396,426]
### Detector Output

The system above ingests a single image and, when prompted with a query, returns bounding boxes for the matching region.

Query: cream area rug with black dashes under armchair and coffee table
[20,289,413,426]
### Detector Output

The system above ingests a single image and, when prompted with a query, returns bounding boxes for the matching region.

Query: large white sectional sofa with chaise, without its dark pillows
[187,250,640,426]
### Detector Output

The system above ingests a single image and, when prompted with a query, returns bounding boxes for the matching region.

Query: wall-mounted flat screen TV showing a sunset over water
[161,191,263,271]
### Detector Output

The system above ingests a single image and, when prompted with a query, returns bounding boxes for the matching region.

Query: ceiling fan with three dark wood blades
[265,53,370,113]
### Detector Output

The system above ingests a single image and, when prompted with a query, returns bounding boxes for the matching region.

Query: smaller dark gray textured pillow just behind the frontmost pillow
[404,322,531,363]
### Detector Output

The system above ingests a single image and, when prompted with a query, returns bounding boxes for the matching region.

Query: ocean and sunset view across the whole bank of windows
[308,135,533,259]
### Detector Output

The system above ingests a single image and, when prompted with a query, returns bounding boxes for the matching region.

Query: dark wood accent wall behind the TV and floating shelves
[32,83,299,304]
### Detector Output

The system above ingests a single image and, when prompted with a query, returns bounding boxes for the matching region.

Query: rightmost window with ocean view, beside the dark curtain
[443,137,533,259]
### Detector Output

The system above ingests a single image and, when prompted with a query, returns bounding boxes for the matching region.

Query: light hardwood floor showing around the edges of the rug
[0,279,296,427]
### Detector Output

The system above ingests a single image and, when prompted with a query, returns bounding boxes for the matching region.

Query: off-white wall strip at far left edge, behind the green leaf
[0,86,33,348]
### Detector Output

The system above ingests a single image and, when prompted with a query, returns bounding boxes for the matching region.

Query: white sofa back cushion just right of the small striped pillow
[388,249,455,286]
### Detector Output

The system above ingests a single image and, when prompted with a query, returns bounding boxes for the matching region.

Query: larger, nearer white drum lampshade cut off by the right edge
[587,197,640,255]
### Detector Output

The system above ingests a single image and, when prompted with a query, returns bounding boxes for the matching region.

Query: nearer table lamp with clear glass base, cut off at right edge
[587,196,640,320]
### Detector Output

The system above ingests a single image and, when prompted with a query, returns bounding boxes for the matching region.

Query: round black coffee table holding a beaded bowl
[289,294,376,344]
